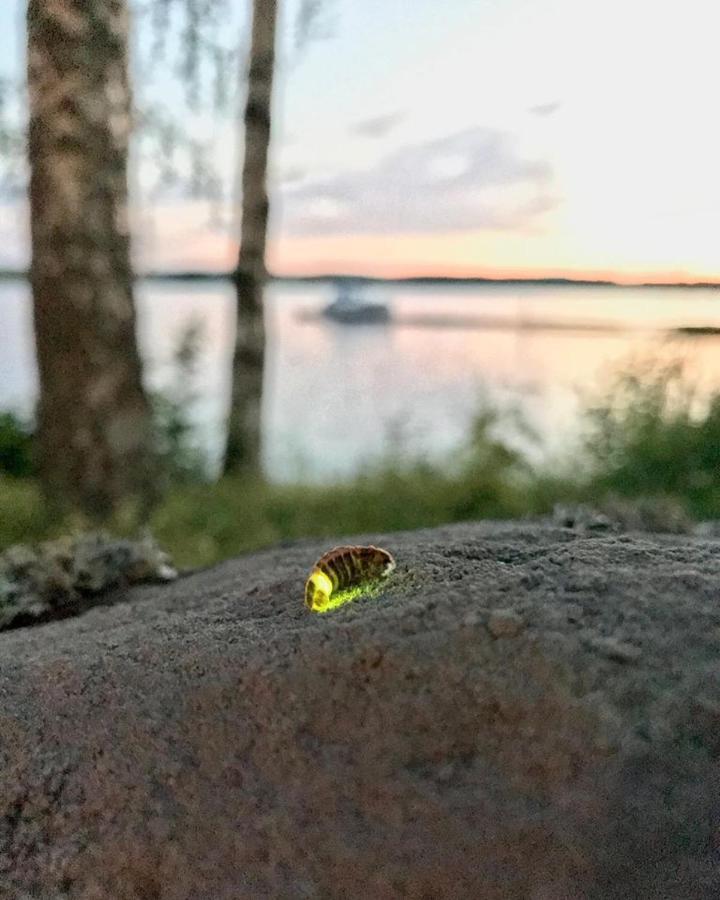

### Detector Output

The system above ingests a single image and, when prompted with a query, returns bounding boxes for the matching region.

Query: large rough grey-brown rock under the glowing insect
[0,523,720,900]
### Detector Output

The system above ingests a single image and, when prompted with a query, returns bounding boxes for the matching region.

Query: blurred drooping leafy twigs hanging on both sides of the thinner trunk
[131,0,332,227]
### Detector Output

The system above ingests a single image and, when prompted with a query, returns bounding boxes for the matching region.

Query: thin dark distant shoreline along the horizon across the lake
[0,269,720,290]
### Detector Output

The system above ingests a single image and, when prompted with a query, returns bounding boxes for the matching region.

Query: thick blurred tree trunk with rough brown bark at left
[27,0,153,518]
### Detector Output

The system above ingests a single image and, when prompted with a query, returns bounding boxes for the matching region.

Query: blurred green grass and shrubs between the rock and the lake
[0,363,720,566]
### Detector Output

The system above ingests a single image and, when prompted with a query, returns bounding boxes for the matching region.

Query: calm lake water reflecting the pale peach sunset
[0,282,720,480]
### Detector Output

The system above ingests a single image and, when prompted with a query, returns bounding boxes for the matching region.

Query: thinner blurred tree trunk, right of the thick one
[225,0,277,474]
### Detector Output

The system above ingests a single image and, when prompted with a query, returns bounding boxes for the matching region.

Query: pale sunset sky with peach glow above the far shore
[0,0,720,282]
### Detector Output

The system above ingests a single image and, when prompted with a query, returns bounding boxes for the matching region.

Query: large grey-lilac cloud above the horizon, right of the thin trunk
[280,128,556,236]
